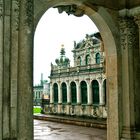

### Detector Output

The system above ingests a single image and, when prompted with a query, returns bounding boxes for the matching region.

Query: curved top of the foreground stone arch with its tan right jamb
[34,0,121,140]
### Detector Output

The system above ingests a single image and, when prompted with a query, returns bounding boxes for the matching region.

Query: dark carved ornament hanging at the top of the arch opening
[54,4,85,17]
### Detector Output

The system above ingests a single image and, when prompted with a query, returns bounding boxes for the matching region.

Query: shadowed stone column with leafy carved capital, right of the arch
[120,17,136,140]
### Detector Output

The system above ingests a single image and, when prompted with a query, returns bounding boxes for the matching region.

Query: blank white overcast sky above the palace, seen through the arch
[34,8,98,85]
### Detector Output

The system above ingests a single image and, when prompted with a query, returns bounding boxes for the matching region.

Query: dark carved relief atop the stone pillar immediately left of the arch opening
[26,0,33,26]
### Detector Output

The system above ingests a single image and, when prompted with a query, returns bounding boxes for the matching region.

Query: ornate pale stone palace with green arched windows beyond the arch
[50,32,107,118]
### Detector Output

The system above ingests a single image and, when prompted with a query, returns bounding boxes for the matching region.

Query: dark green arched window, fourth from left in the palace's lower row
[80,81,87,104]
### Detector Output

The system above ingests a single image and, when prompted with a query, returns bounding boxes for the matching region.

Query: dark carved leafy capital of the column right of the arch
[119,17,136,49]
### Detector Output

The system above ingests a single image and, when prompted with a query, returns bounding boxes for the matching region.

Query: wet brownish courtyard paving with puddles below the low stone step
[34,120,107,140]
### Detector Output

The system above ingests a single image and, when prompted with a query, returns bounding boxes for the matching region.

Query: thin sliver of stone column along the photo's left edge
[0,0,3,140]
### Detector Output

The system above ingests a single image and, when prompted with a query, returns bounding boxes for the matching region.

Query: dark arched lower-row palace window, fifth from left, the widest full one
[92,80,99,104]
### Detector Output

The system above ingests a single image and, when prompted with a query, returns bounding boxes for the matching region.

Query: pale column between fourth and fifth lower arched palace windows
[87,80,93,105]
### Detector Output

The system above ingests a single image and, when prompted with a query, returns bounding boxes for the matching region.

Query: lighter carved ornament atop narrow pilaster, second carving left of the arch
[12,0,19,30]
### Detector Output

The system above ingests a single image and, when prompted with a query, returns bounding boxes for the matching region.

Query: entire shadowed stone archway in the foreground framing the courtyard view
[0,0,140,140]
